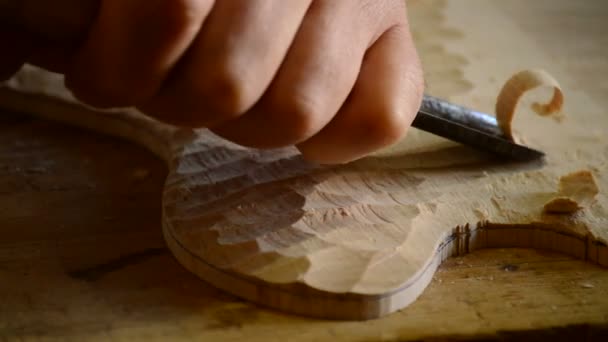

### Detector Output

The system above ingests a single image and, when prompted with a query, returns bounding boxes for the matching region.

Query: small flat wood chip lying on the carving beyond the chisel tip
[543,170,599,214]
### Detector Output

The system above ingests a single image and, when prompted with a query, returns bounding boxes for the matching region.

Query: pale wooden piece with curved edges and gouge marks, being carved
[0,1,608,319]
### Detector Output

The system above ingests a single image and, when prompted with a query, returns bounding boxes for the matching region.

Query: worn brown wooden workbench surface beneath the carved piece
[0,0,608,341]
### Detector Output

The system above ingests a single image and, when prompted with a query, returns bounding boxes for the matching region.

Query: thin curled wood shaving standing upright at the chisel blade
[496,69,564,139]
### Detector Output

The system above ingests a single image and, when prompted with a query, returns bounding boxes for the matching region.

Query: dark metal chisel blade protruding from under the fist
[412,96,545,161]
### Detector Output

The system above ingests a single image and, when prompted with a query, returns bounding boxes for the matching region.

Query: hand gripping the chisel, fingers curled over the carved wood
[1,0,423,163]
